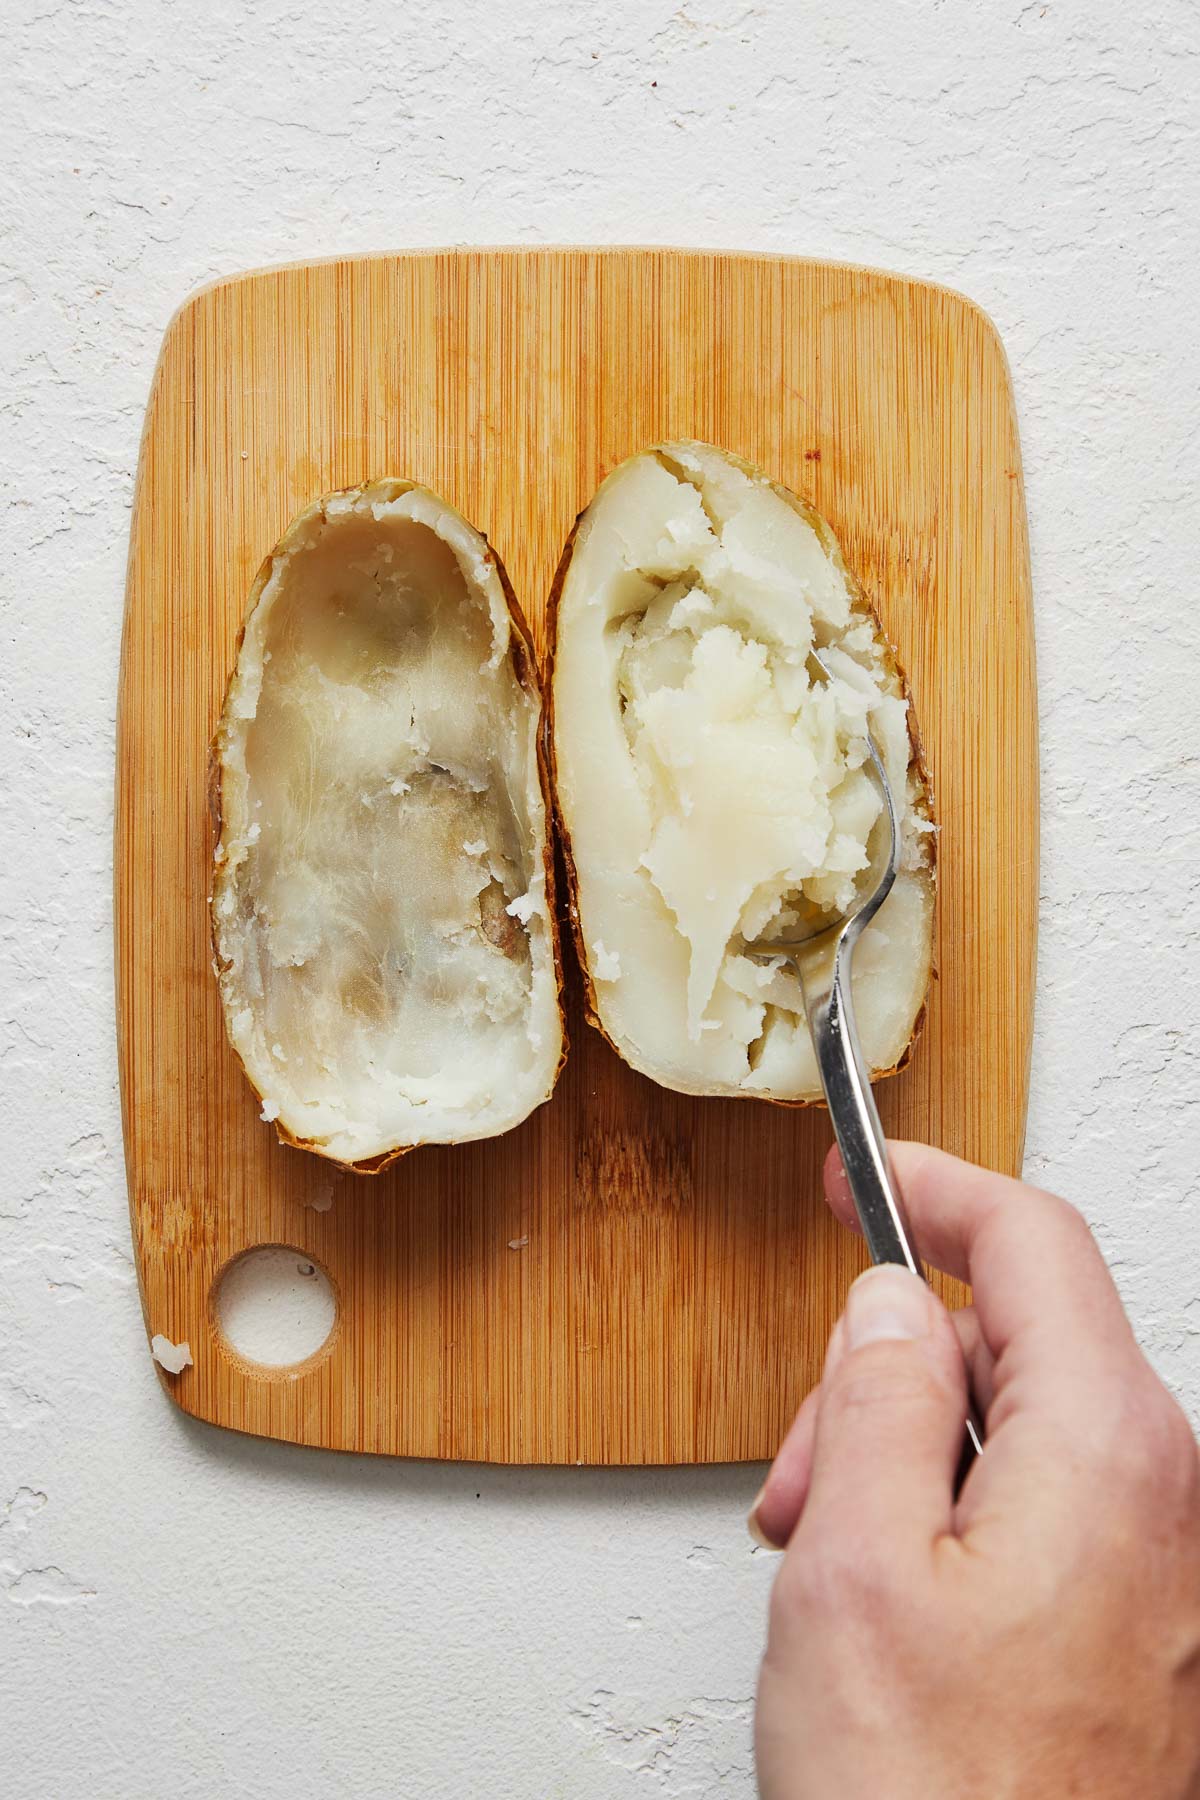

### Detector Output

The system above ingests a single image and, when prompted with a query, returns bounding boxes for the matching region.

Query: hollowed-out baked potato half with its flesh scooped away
[212,481,563,1170]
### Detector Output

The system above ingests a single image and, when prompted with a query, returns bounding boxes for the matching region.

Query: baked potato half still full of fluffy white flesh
[551,443,934,1102]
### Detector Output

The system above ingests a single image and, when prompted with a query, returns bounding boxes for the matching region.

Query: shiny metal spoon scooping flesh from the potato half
[741,650,982,1485]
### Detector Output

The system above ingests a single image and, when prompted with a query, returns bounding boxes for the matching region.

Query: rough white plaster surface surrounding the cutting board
[0,0,1200,1800]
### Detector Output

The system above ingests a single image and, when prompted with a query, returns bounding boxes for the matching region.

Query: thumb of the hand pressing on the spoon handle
[797,1265,966,1557]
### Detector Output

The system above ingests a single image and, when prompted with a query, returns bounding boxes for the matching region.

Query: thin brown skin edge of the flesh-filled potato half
[543,445,937,1107]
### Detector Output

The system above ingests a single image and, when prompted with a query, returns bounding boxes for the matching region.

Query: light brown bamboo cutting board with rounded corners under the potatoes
[117,250,1038,1463]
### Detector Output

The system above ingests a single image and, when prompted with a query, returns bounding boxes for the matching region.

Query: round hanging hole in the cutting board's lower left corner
[212,1244,338,1372]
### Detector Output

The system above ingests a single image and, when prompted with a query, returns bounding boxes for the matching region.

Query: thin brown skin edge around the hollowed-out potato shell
[209,477,569,1175]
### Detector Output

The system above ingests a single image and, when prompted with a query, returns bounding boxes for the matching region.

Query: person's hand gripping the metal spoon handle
[750,1143,1200,1800]
